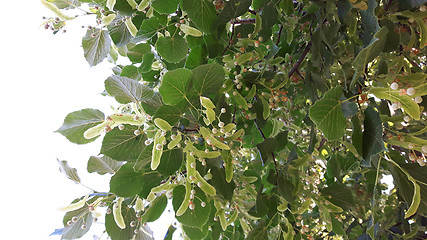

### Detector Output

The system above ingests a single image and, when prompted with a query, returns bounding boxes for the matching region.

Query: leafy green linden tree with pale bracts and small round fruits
[42,0,427,240]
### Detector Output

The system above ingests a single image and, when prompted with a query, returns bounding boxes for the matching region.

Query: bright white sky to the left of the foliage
[0,0,174,240]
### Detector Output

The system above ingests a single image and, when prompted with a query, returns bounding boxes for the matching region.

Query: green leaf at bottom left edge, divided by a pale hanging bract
[105,204,138,240]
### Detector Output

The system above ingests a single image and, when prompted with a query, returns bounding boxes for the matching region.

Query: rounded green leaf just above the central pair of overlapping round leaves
[156,35,188,63]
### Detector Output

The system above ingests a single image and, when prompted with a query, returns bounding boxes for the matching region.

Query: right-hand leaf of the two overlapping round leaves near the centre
[192,63,225,96]
